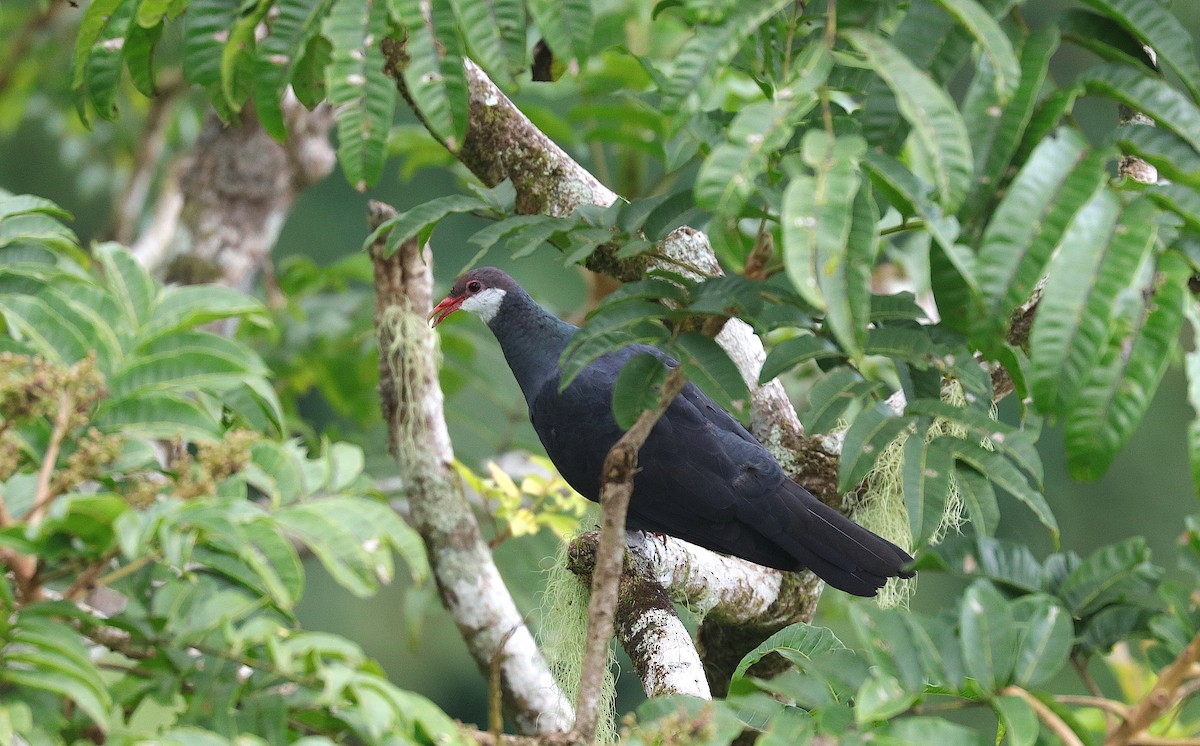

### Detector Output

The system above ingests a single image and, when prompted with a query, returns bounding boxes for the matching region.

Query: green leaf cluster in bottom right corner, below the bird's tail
[630,519,1200,746]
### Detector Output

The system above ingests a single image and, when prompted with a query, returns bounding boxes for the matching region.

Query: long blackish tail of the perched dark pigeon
[770,480,914,596]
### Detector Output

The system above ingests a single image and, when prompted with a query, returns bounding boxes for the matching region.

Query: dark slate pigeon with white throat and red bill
[430,267,913,596]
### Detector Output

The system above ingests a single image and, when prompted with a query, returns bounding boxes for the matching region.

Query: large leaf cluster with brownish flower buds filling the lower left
[0,194,457,744]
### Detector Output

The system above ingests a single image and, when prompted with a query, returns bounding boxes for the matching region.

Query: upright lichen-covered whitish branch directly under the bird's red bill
[371,203,574,734]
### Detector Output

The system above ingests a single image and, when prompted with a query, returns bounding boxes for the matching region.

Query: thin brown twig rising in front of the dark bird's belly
[575,367,686,744]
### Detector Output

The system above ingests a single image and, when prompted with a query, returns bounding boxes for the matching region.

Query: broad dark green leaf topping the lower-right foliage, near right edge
[1055,536,1163,619]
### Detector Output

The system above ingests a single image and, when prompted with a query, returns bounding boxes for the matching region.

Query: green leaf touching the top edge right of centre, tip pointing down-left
[662,0,788,112]
